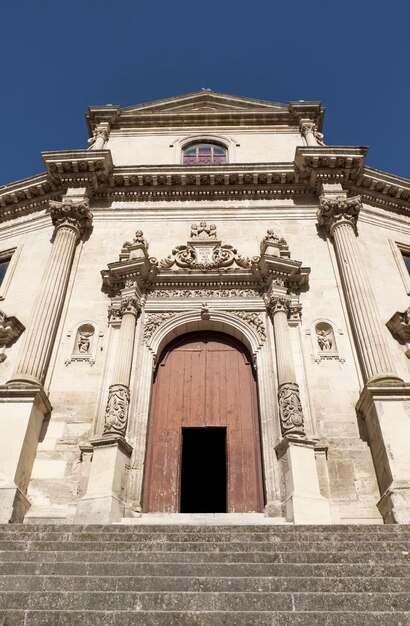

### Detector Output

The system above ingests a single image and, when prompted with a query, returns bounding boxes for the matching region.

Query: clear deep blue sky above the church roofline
[0,0,410,184]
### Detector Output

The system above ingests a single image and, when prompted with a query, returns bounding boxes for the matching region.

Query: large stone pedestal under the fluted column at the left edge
[0,385,51,523]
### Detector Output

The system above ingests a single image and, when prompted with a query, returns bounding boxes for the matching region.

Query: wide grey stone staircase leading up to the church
[0,524,410,626]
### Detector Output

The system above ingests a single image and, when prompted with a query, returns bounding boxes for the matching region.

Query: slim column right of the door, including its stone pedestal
[268,294,331,524]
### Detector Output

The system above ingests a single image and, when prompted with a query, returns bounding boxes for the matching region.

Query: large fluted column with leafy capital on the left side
[9,198,92,386]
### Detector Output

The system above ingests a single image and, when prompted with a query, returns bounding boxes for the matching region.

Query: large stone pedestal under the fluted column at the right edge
[356,384,410,524]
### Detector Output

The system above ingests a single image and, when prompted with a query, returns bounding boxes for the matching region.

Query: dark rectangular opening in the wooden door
[180,427,227,513]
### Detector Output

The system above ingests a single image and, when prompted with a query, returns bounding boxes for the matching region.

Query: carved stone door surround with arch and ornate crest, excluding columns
[94,221,316,515]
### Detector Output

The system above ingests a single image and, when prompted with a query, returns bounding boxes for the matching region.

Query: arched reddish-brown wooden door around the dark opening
[143,332,263,512]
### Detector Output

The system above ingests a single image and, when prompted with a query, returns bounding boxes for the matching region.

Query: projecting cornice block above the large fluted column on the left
[41,149,113,192]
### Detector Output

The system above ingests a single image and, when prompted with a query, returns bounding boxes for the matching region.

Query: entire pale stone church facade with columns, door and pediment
[0,91,410,524]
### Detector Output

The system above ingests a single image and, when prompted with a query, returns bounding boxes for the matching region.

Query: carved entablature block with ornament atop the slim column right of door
[252,229,310,289]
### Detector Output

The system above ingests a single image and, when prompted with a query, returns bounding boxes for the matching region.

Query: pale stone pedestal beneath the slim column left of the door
[74,435,132,524]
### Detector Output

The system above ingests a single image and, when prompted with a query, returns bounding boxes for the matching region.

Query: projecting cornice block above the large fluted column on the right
[295,146,367,193]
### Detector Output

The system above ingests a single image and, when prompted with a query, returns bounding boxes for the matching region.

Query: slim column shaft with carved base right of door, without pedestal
[268,296,306,437]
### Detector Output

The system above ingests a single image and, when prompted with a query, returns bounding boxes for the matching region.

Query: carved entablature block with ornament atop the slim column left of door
[101,230,158,295]
